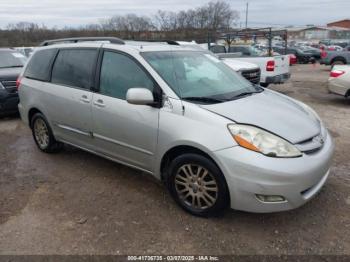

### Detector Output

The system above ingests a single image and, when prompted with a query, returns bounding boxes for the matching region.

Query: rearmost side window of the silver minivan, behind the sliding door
[24,49,57,81]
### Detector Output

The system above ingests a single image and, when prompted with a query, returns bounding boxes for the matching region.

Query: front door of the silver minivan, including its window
[92,50,159,172]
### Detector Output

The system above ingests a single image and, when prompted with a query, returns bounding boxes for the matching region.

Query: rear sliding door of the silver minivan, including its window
[46,48,98,148]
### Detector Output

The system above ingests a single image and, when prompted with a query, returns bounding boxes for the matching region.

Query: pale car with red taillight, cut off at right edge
[328,65,350,97]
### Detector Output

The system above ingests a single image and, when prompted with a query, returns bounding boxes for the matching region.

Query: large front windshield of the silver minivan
[141,51,263,103]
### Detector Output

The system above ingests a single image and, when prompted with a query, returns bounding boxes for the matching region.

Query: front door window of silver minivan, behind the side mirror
[100,51,155,100]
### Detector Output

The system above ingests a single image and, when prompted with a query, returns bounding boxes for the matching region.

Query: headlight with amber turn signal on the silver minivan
[227,124,302,157]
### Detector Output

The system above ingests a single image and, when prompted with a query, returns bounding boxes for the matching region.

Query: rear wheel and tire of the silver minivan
[30,113,63,153]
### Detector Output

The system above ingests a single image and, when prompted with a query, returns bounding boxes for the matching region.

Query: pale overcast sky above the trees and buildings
[0,0,350,28]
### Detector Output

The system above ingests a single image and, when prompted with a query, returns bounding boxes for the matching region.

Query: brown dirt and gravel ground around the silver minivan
[0,65,350,255]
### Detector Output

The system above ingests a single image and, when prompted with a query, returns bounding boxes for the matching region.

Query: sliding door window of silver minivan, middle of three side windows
[51,49,97,89]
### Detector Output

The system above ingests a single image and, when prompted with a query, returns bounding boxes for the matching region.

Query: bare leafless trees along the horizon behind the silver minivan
[0,0,239,46]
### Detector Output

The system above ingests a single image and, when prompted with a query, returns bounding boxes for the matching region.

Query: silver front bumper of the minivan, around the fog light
[215,129,334,213]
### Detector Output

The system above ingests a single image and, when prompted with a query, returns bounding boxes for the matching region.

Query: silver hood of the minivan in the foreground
[201,90,321,144]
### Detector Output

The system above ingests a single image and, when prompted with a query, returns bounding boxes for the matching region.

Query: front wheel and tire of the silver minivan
[166,154,230,217]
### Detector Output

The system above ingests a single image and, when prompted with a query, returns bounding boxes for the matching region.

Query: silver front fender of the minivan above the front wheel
[155,98,237,178]
